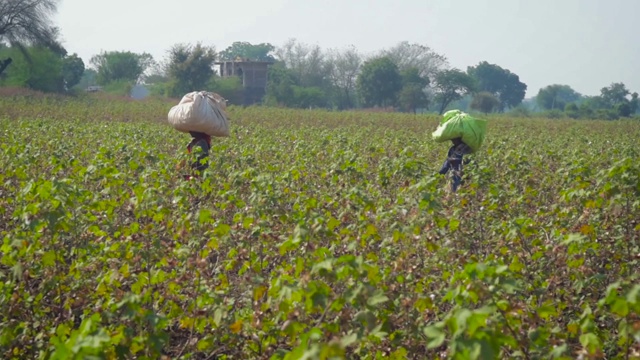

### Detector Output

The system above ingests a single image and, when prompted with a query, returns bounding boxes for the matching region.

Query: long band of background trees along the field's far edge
[0,40,639,119]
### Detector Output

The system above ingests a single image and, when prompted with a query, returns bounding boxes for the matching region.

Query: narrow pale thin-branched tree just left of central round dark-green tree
[328,47,362,109]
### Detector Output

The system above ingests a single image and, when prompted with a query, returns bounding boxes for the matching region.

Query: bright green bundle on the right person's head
[431,110,487,152]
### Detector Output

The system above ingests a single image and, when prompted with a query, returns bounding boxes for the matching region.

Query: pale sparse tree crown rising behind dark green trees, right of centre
[382,41,447,79]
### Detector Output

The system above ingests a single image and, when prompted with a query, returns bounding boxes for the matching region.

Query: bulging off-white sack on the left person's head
[169,91,229,137]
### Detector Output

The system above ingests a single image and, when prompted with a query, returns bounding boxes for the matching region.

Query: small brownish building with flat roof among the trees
[216,58,273,105]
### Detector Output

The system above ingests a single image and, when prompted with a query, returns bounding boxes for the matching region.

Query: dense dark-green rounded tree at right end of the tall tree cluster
[467,61,527,111]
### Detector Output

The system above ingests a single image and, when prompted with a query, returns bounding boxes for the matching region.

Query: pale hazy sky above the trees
[55,0,640,97]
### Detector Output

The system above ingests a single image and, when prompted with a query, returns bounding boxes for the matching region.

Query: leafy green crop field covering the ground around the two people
[0,75,640,359]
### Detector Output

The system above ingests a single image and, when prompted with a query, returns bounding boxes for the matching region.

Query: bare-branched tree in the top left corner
[0,0,66,74]
